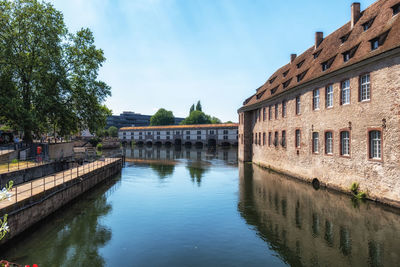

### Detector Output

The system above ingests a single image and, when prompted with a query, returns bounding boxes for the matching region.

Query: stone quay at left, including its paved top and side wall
[0,158,124,247]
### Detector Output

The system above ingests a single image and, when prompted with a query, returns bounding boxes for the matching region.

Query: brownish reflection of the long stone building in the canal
[238,164,400,266]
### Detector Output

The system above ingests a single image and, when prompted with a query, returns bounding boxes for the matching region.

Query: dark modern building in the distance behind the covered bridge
[106,111,184,129]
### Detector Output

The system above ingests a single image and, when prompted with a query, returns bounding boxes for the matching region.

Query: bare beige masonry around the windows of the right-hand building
[239,57,400,207]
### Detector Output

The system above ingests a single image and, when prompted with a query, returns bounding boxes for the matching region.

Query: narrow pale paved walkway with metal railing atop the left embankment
[0,158,119,210]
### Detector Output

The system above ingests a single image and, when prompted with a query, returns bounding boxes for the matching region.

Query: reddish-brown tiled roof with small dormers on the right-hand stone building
[243,0,400,107]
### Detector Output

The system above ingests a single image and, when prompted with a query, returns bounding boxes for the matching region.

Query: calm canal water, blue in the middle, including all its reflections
[0,147,400,267]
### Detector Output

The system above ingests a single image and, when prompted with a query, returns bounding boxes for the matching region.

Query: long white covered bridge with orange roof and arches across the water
[118,123,238,146]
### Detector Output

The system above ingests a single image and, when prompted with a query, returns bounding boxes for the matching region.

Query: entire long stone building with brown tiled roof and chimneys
[238,0,400,207]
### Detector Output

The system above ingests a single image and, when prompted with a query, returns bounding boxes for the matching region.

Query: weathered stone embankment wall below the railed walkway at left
[0,160,122,246]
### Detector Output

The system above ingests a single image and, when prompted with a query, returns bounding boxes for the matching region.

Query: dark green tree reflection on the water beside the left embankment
[0,174,119,266]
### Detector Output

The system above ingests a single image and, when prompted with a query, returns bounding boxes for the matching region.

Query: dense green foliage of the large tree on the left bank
[0,0,111,141]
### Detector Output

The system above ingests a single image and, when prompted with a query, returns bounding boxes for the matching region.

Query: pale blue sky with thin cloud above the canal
[50,0,374,122]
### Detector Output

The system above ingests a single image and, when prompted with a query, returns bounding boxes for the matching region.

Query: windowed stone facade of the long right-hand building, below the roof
[239,1,400,207]
